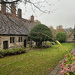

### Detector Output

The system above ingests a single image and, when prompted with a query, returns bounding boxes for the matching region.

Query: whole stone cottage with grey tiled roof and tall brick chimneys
[0,4,35,49]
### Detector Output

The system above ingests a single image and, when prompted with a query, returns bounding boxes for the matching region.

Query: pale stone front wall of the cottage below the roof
[0,36,27,50]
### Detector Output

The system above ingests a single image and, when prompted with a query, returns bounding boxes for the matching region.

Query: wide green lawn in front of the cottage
[0,43,74,75]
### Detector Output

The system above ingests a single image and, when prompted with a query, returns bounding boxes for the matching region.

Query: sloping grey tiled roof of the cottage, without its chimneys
[0,14,35,35]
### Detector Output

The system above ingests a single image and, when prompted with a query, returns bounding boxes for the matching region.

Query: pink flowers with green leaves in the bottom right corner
[60,53,75,75]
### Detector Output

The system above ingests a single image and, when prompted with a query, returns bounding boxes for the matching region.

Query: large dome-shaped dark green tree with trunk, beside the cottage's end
[29,24,52,46]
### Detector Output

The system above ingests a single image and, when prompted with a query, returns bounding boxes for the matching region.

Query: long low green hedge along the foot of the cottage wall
[0,48,26,58]
